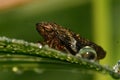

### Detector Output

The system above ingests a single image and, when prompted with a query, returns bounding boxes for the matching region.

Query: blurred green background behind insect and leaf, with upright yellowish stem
[0,0,120,80]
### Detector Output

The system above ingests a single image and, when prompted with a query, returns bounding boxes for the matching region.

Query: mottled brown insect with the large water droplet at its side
[36,22,106,61]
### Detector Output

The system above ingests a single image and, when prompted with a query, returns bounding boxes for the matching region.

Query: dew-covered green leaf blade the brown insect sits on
[0,37,120,78]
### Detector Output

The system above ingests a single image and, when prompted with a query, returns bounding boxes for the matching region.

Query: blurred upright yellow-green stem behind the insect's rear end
[92,0,114,80]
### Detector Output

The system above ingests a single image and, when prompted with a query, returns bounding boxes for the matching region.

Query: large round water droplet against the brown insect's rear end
[76,46,97,61]
